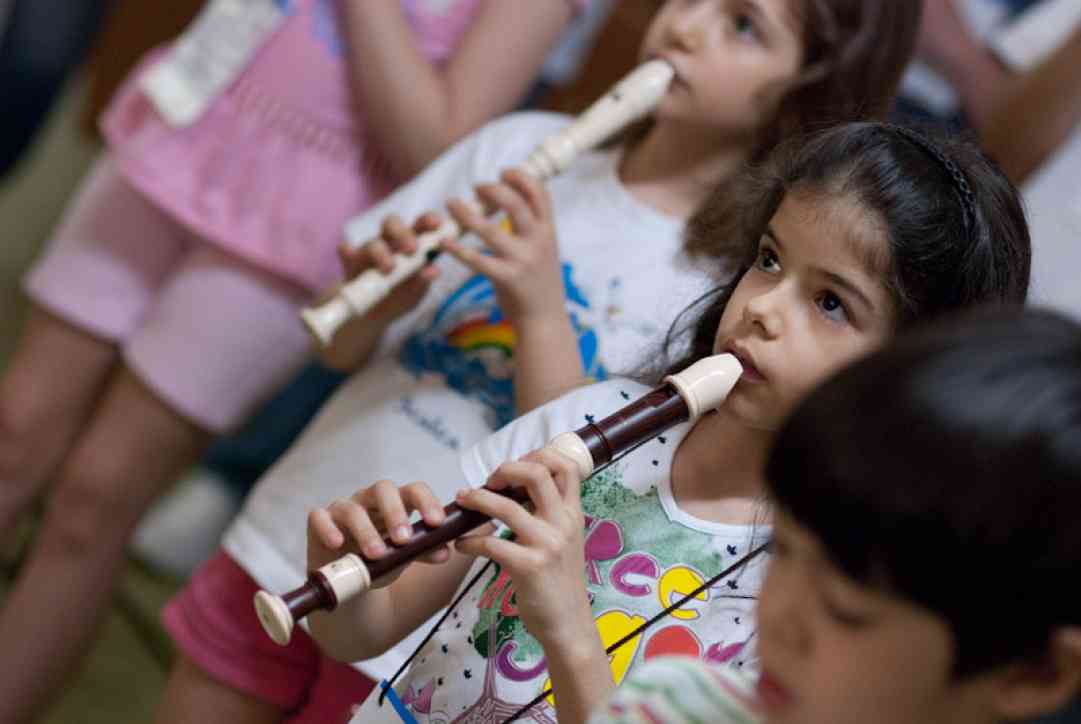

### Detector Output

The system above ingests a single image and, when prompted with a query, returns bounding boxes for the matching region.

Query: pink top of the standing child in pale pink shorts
[102,0,490,291]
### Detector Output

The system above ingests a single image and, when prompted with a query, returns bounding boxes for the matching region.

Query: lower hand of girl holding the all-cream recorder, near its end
[338,212,442,322]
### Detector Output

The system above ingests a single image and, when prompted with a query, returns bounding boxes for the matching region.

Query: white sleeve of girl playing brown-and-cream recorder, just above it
[459,379,650,486]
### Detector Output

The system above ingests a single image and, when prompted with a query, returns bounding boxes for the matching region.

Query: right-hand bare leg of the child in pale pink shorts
[0,367,210,724]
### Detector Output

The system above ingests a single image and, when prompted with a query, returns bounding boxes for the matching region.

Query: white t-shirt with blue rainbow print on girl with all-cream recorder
[223,112,709,679]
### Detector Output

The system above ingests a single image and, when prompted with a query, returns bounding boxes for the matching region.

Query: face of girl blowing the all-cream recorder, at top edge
[642,0,803,136]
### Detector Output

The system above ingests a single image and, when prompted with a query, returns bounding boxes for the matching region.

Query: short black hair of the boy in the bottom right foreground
[766,309,1081,678]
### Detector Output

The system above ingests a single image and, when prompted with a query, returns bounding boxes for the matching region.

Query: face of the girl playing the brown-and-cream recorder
[713,192,895,430]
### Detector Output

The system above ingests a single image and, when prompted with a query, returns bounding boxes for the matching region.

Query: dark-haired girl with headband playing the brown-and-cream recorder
[308,123,1029,722]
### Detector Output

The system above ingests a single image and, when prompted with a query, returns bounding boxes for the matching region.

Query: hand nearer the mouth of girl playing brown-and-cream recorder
[455,448,599,649]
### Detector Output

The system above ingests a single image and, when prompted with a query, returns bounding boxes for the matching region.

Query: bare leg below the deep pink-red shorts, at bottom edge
[155,656,285,724]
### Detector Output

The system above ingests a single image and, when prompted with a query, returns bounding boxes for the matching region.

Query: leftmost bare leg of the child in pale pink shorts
[0,307,117,536]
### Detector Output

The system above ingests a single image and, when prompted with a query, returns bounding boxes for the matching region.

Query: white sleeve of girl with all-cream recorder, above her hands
[345,112,568,246]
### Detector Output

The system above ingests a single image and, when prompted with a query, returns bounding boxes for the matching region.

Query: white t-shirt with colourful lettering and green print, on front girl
[353,379,769,724]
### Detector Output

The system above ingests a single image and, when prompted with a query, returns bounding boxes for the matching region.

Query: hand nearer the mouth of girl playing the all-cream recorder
[443,169,566,324]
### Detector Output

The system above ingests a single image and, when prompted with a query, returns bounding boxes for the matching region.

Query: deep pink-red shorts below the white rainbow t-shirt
[162,551,375,724]
